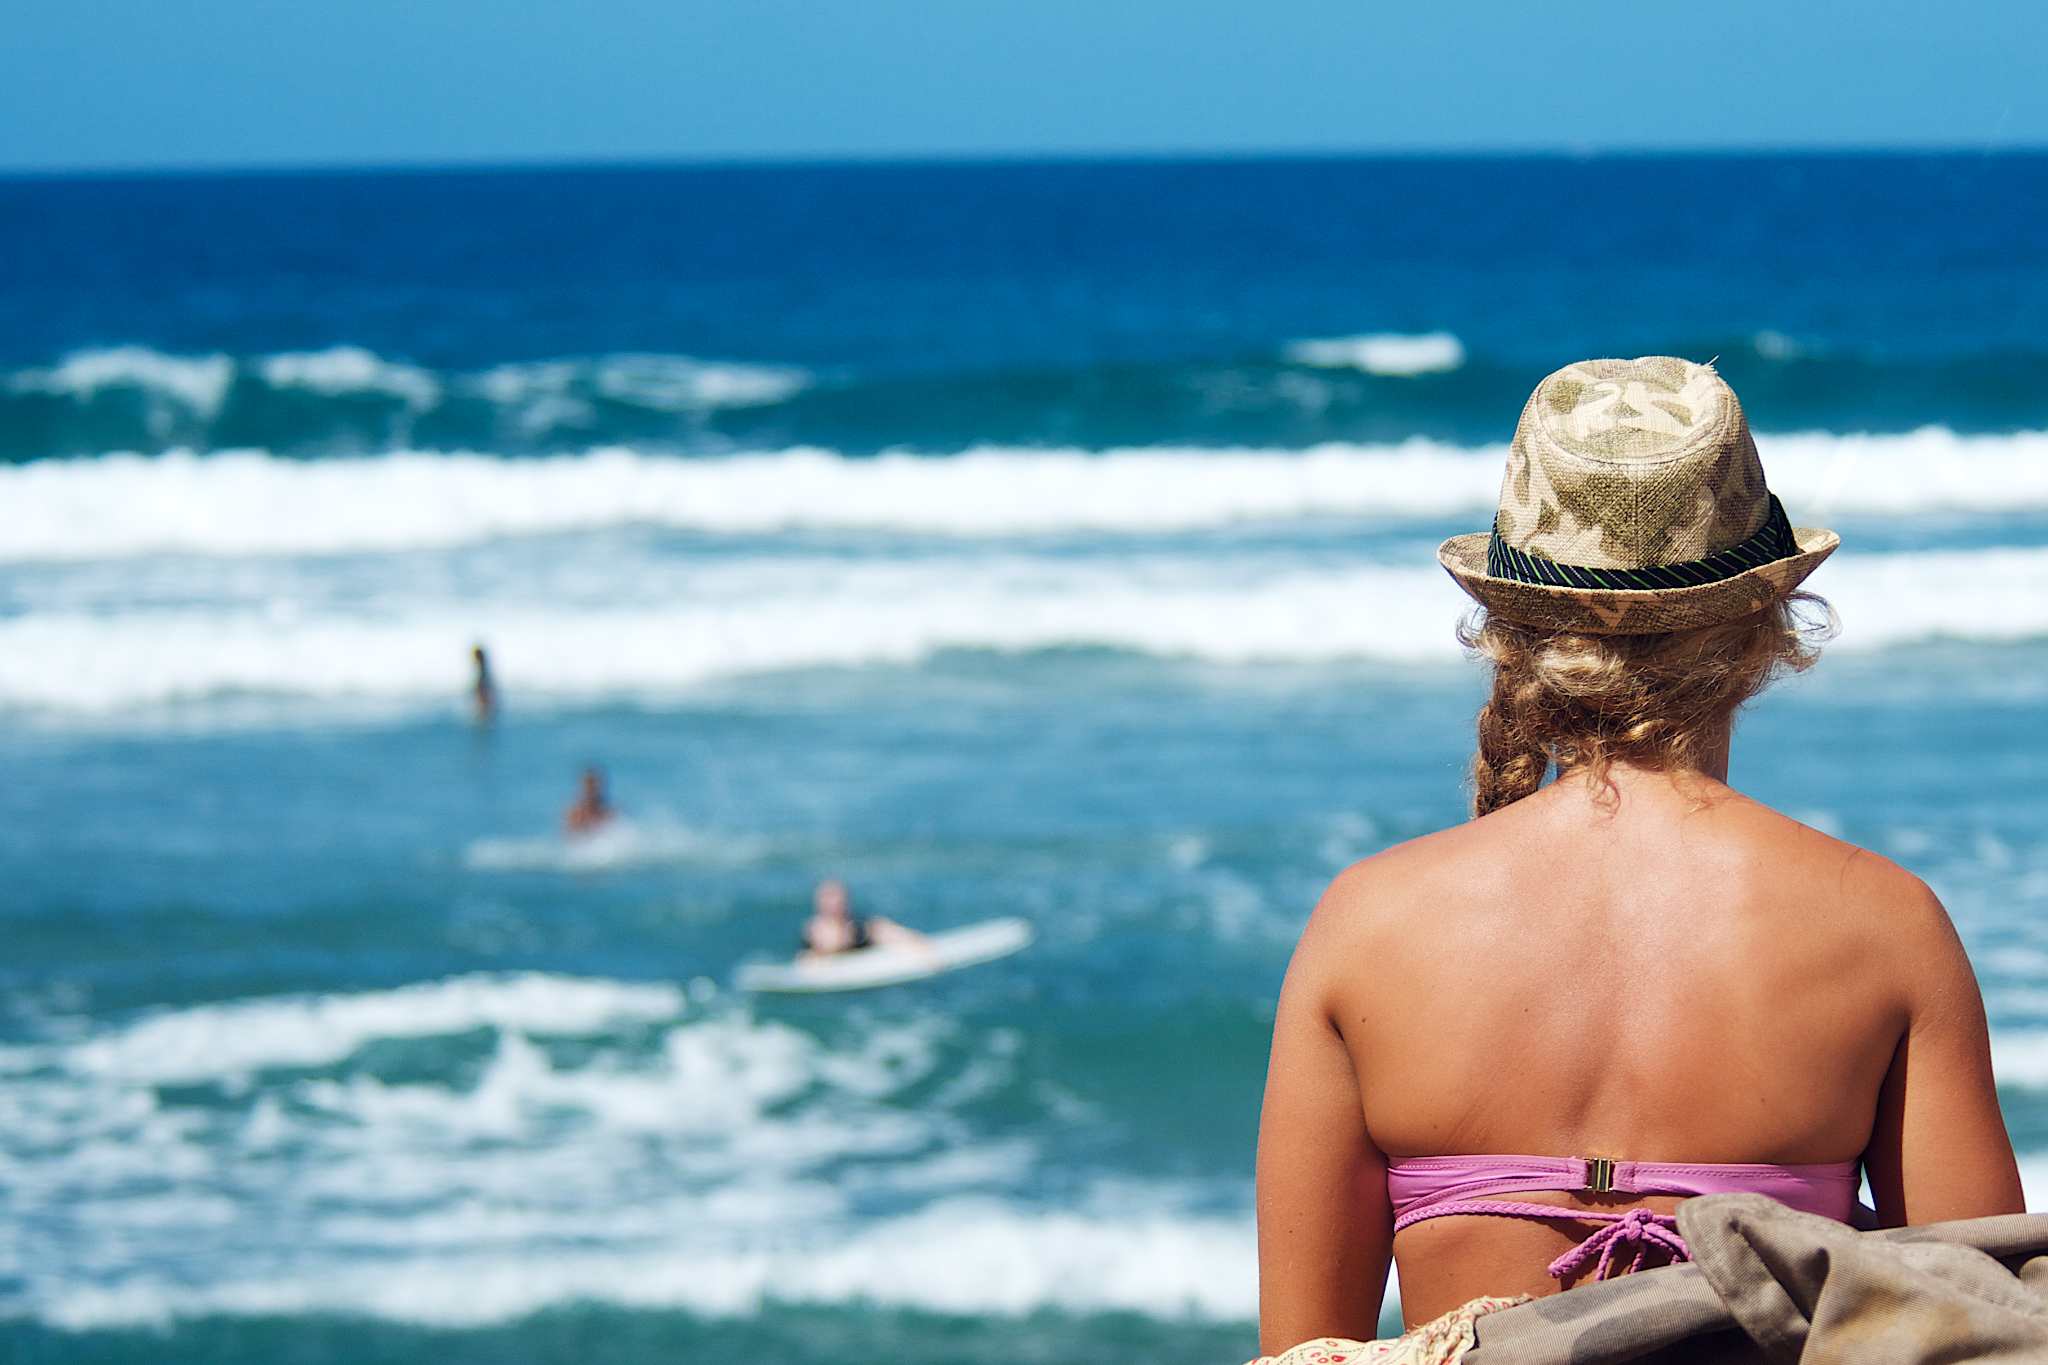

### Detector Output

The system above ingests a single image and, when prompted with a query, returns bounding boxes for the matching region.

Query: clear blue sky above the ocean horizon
[0,0,2048,170]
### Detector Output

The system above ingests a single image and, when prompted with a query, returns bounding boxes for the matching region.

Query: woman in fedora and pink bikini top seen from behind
[1257,356,2021,1349]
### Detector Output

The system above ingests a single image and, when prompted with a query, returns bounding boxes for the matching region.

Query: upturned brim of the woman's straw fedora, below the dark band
[1436,526,1841,634]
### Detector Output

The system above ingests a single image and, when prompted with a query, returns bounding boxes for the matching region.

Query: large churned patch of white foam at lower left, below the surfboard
[0,978,1179,1328]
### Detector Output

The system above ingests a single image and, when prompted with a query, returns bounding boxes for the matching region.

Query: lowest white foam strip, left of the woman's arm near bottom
[19,1197,1257,1330]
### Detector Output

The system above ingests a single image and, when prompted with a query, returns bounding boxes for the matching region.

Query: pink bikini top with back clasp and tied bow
[1386,1156,1860,1279]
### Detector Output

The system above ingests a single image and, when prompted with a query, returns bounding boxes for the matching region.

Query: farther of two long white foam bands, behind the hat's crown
[12,428,2048,561]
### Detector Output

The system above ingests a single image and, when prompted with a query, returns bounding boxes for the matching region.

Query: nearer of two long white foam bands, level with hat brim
[12,544,2048,716]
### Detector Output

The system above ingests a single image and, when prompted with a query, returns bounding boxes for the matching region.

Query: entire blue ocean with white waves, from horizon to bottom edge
[0,153,2048,1365]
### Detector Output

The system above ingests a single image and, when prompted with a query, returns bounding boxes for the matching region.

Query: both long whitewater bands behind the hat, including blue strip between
[0,428,2048,718]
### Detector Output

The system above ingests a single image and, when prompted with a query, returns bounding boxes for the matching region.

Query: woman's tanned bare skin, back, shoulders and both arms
[1257,741,2025,1353]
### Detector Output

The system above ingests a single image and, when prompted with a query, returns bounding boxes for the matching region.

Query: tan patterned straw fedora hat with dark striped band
[1436,356,1841,634]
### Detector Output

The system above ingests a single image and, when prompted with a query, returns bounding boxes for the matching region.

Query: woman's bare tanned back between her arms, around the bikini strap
[1311,772,1941,1320]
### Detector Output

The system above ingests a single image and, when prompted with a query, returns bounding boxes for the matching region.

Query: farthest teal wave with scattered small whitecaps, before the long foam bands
[0,332,2048,465]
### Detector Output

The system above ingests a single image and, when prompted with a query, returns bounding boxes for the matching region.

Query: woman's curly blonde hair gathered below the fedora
[1458,593,1835,817]
